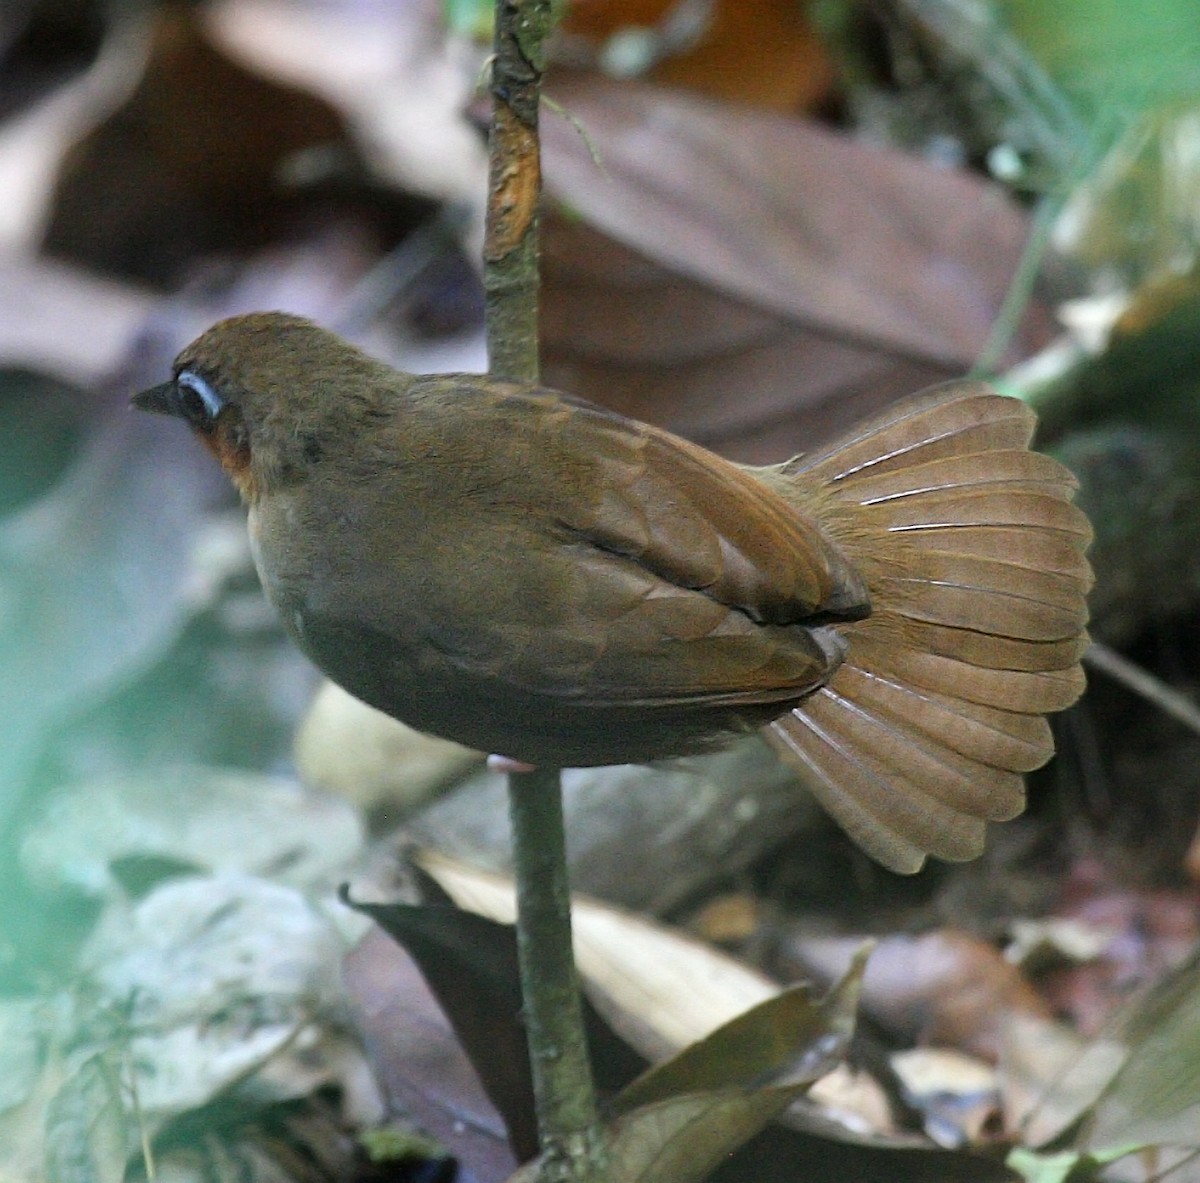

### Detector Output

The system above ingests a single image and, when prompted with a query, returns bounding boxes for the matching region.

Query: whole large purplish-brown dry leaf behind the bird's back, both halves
[542,80,1046,460]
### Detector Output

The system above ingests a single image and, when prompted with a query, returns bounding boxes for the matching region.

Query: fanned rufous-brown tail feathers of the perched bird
[766,382,1092,871]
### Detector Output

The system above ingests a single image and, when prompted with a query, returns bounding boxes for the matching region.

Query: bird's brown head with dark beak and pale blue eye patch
[133,312,398,502]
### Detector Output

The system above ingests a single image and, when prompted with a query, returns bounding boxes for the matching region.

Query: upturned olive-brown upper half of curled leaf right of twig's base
[616,948,870,1112]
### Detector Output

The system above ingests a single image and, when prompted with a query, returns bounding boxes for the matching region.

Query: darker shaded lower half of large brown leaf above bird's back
[542,217,953,463]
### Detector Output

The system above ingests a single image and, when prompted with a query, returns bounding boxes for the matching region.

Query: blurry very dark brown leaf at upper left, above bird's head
[43,5,354,283]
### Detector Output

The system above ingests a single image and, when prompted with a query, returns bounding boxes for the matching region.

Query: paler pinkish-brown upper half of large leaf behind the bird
[542,79,1038,366]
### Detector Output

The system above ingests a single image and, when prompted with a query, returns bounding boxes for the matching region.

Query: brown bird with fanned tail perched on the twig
[133,312,1092,872]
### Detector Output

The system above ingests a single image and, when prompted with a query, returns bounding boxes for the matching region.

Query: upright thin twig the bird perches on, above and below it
[484,0,607,1183]
